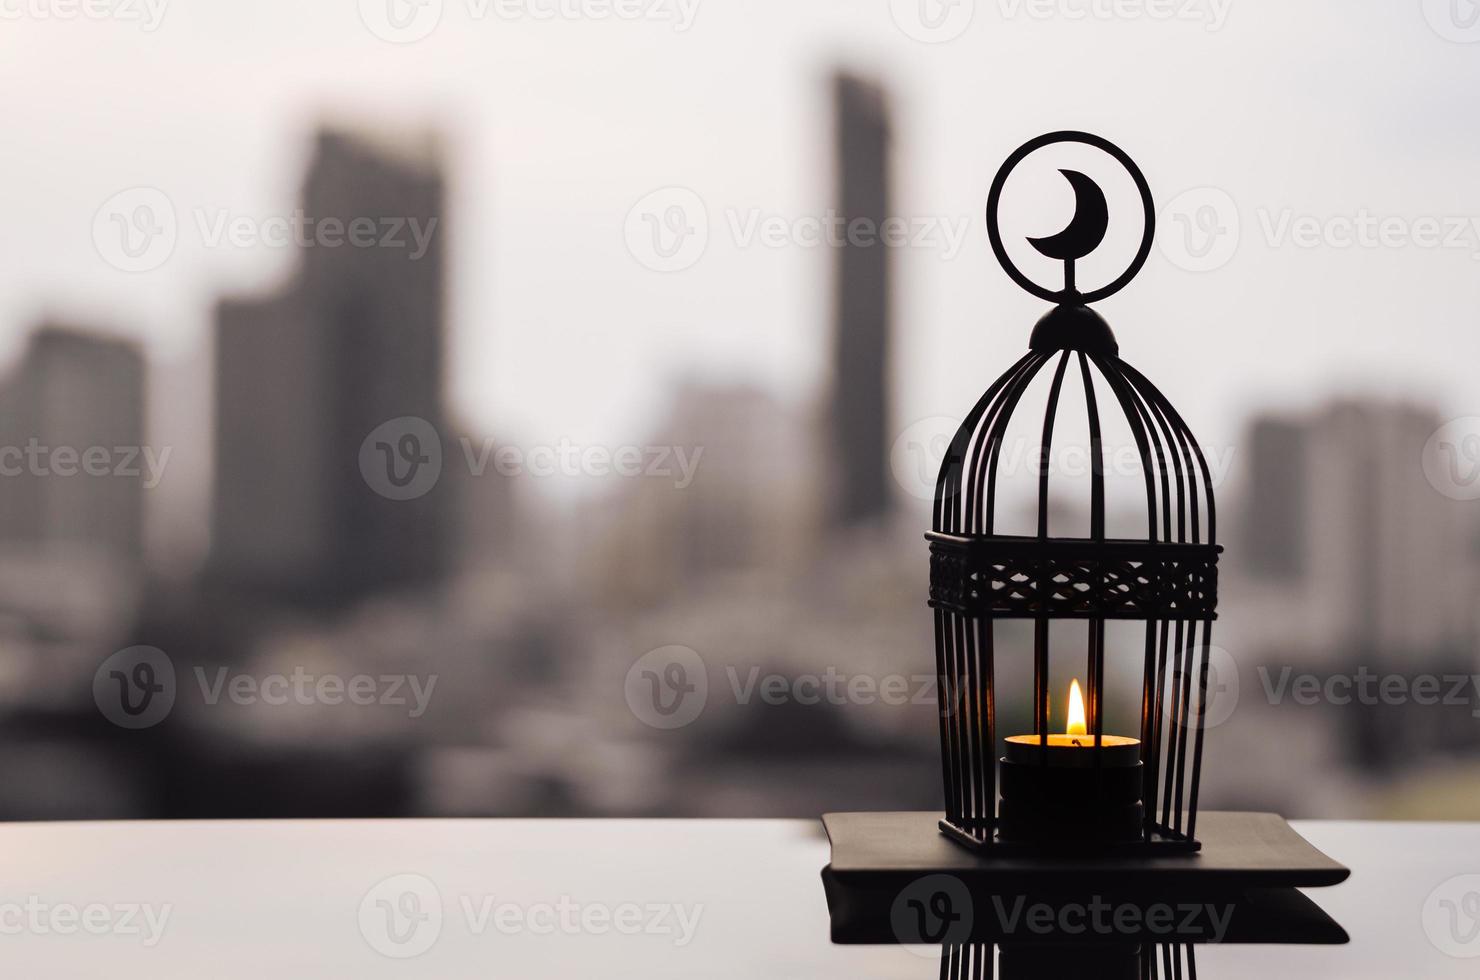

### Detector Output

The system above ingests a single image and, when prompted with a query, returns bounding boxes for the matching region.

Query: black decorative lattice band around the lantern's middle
[925,533,1222,619]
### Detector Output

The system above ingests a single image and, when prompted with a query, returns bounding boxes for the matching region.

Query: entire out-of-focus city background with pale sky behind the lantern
[0,0,1480,817]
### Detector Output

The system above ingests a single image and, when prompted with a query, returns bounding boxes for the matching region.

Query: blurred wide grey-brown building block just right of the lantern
[1230,400,1476,665]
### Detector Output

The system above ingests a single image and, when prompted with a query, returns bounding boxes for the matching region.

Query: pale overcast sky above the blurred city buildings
[0,0,1480,556]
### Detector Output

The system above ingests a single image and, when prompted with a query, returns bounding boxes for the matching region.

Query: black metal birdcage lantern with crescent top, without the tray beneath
[926,132,1221,851]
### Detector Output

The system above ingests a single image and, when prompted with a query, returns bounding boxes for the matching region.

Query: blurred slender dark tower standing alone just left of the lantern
[830,75,892,526]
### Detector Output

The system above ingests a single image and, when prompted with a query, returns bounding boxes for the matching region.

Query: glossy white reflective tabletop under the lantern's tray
[0,820,1480,980]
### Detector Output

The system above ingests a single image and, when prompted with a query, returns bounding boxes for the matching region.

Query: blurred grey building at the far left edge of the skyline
[0,326,147,564]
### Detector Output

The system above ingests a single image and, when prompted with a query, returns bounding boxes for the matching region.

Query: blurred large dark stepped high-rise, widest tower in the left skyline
[212,132,453,604]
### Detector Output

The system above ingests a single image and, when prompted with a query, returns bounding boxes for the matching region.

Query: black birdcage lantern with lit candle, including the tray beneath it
[823,132,1350,942]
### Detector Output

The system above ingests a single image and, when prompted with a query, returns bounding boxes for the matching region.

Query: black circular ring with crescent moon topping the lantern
[987,130,1156,306]
